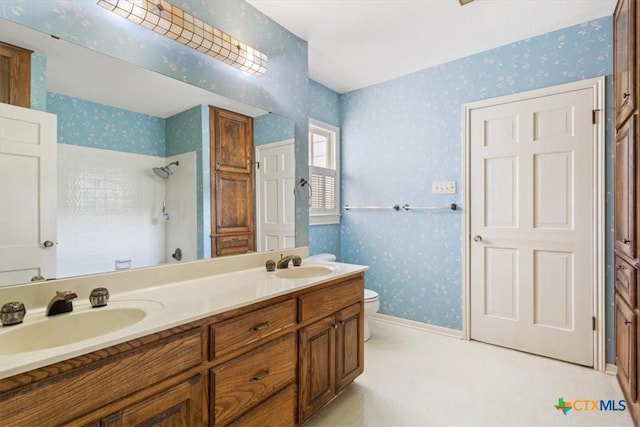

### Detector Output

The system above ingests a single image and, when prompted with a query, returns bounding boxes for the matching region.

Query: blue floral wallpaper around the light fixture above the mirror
[0,0,309,245]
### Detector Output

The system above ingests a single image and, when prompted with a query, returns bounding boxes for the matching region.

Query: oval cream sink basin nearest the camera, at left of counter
[0,304,160,355]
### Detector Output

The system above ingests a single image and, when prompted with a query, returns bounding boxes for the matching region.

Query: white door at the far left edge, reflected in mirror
[0,103,57,286]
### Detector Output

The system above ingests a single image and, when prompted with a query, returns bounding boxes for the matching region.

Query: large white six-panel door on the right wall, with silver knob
[468,84,596,366]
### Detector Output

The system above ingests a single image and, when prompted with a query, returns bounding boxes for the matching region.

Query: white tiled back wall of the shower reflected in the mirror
[57,144,166,277]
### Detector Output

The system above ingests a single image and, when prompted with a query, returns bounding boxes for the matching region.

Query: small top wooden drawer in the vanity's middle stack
[210,300,296,358]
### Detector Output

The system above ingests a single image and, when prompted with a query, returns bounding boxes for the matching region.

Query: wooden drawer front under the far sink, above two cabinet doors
[298,276,364,322]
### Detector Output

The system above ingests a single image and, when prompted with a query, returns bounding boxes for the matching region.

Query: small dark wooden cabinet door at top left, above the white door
[0,42,31,108]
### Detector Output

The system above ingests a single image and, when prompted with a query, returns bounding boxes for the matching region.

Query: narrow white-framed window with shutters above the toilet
[309,120,340,225]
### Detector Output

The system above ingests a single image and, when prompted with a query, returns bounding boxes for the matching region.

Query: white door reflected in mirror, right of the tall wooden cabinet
[256,139,295,251]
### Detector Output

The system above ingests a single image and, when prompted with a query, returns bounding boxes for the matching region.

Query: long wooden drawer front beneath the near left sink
[0,328,203,426]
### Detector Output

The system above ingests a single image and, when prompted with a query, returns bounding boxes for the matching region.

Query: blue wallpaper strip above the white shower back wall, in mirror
[47,92,166,157]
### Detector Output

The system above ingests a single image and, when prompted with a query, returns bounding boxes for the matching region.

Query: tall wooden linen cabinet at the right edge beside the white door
[613,0,640,425]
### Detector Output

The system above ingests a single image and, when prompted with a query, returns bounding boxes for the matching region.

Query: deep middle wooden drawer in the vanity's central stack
[211,334,296,425]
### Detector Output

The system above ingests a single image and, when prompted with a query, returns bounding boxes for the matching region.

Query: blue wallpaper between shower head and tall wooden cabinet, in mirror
[166,105,211,259]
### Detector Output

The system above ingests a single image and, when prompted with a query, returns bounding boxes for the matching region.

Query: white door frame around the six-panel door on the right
[462,77,606,372]
